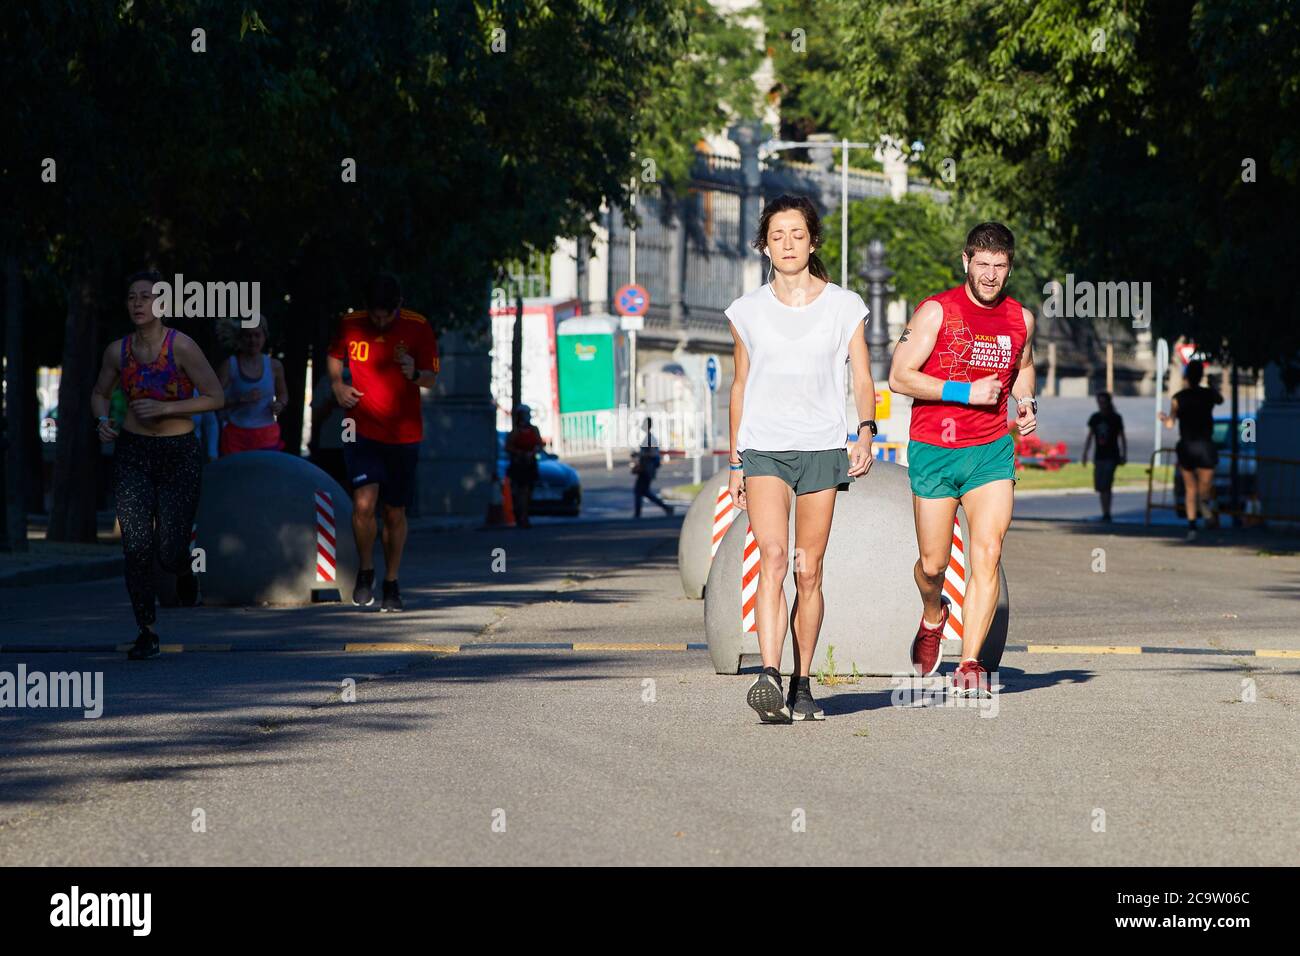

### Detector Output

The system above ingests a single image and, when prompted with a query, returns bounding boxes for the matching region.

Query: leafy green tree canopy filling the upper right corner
[832,0,1300,365]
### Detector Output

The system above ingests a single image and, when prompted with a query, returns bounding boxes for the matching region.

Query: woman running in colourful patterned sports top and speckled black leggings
[90,272,225,661]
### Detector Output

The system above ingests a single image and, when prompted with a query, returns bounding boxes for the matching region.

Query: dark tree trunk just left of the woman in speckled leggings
[49,269,101,542]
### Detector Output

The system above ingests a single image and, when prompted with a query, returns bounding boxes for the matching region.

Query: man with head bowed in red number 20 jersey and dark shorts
[329,274,438,611]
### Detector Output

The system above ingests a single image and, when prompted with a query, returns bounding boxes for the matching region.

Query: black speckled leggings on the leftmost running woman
[113,431,203,627]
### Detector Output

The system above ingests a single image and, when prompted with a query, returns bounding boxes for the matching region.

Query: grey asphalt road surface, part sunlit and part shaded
[0,489,1300,865]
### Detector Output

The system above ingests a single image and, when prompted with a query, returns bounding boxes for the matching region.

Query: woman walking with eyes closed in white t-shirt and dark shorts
[725,195,876,723]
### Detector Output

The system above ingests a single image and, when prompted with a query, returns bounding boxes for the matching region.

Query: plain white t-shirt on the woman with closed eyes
[725,282,867,454]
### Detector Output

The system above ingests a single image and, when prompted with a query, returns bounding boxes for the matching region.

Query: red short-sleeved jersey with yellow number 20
[329,308,438,445]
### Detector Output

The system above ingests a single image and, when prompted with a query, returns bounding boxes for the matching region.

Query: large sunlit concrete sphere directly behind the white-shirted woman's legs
[705,460,1010,676]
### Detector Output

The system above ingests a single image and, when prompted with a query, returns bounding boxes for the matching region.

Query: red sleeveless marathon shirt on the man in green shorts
[911,285,1024,449]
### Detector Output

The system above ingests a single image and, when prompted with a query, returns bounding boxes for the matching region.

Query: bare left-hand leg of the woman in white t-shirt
[745,475,793,669]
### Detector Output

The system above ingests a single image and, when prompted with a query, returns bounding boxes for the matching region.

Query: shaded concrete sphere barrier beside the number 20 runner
[180,451,358,605]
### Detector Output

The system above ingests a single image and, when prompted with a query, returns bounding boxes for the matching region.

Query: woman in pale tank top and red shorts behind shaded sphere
[220,315,289,455]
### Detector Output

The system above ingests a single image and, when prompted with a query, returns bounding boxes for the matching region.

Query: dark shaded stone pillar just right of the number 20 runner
[416,319,497,522]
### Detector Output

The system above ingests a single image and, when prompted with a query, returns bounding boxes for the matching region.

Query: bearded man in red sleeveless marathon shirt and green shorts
[889,222,1037,697]
